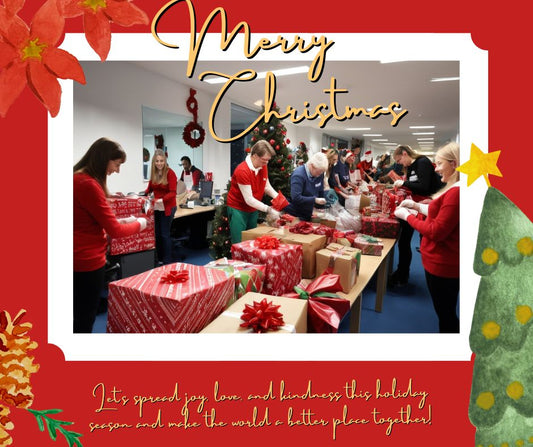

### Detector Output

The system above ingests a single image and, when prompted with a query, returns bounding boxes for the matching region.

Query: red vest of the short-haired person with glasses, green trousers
[226,160,268,213]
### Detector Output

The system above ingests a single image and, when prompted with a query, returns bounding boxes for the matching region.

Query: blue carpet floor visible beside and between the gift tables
[93,232,439,334]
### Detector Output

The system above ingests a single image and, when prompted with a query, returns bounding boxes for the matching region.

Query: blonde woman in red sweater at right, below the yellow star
[394,143,459,333]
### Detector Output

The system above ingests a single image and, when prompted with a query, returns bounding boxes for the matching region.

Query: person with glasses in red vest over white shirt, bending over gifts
[226,140,280,244]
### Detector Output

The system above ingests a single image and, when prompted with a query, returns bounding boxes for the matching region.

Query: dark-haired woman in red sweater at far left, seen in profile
[73,138,146,333]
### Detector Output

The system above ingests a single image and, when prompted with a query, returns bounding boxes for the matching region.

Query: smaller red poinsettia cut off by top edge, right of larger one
[58,0,148,61]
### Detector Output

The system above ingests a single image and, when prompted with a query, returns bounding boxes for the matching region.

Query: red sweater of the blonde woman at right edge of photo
[407,186,459,278]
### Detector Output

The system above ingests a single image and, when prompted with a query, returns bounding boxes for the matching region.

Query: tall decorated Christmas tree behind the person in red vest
[251,103,294,203]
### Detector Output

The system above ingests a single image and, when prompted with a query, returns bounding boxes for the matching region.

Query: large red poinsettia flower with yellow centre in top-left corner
[0,0,85,116]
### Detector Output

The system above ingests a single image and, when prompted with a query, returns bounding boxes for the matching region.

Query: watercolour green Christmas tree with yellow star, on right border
[458,145,533,447]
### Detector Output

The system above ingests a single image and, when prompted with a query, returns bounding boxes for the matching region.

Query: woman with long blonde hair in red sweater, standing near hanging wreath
[146,149,178,265]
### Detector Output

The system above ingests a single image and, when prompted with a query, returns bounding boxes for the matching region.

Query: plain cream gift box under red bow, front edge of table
[201,292,307,334]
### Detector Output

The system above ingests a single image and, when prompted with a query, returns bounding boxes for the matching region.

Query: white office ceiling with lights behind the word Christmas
[132,61,459,152]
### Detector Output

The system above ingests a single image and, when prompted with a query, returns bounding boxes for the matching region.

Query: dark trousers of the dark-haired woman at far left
[74,267,105,334]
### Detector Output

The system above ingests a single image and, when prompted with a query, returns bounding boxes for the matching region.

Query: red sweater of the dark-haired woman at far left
[74,174,141,272]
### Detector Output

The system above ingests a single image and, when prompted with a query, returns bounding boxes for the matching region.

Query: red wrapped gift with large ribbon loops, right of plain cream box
[284,274,350,333]
